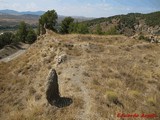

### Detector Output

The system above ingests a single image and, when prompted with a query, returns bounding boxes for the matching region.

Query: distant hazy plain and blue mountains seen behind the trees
[0,9,92,30]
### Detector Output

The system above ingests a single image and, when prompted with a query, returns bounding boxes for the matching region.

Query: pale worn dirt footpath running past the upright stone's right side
[57,54,94,120]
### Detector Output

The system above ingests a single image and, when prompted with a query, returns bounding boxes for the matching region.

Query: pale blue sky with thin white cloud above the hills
[0,0,160,17]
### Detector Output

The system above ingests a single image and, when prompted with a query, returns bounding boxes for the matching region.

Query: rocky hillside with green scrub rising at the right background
[84,11,160,36]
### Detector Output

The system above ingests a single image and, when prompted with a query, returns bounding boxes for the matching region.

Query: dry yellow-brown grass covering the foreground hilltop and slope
[0,33,160,120]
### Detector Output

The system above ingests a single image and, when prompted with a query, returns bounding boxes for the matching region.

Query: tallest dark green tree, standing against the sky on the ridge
[39,10,58,34]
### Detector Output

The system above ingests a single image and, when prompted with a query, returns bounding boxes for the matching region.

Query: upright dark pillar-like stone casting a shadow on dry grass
[46,69,60,105]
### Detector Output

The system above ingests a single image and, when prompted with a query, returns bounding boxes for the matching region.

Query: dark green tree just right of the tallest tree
[60,17,74,34]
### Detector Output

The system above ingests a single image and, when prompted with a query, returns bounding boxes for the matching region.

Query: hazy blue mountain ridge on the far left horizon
[0,9,45,15]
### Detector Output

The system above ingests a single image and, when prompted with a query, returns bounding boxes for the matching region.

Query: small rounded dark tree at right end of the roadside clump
[26,29,37,44]
